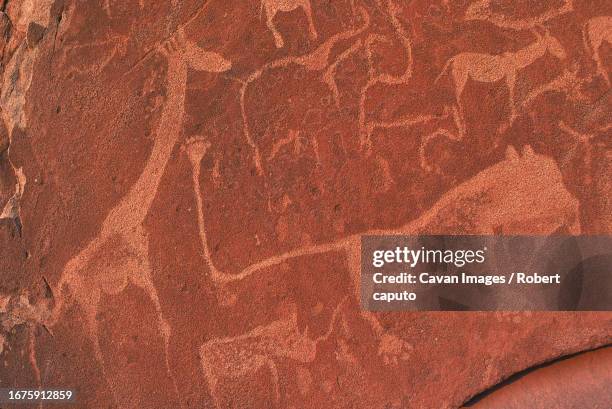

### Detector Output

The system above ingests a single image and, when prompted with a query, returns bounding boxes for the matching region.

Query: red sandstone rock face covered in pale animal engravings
[0,0,612,409]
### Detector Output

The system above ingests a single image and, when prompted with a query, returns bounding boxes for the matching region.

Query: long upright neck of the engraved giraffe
[102,56,187,234]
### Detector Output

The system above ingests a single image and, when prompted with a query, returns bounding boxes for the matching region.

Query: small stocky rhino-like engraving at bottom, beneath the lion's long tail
[199,302,343,407]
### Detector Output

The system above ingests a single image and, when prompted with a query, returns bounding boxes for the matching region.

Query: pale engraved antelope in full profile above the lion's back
[435,30,566,129]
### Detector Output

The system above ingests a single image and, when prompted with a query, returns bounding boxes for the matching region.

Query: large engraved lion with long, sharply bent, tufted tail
[186,139,580,380]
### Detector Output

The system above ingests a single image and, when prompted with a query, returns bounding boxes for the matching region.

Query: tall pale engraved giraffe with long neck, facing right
[50,30,231,404]
